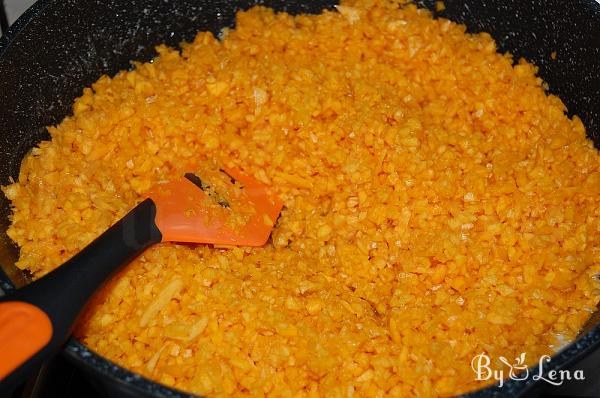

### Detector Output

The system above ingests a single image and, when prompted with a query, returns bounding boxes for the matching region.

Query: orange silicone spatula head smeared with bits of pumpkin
[148,168,283,246]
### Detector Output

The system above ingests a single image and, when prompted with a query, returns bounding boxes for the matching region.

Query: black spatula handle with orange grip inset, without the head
[0,199,162,395]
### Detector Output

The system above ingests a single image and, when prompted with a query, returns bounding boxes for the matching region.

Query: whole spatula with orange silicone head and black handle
[0,169,283,391]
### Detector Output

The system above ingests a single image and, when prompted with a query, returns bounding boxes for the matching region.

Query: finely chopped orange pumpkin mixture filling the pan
[4,0,600,397]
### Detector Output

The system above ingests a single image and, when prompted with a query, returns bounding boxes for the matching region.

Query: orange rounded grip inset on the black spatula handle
[0,301,52,380]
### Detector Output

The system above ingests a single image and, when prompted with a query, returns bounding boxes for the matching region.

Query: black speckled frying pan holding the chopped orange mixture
[0,0,600,397]
